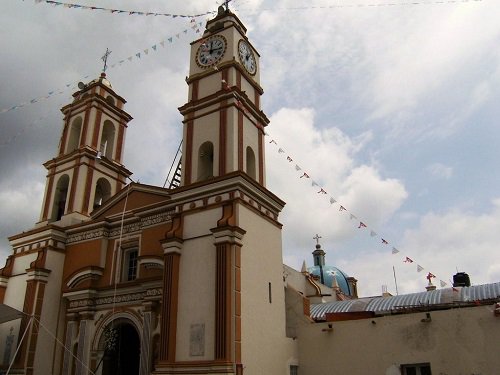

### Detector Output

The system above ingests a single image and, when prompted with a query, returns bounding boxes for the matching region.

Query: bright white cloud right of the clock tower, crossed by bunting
[266,108,407,268]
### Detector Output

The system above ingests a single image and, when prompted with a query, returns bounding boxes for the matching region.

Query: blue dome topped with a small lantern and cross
[307,235,355,296]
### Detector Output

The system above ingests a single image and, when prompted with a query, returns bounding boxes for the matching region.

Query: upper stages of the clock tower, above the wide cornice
[179,6,269,186]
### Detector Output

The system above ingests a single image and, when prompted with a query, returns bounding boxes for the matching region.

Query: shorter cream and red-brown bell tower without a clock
[37,73,132,226]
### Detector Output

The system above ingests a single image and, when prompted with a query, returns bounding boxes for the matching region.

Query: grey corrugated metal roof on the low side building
[311,282,500,320]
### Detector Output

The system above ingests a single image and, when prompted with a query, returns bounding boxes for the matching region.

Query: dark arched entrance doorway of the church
[102,322,141,375]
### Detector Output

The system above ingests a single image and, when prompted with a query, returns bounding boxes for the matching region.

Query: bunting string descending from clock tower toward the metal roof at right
[265,132,448,288]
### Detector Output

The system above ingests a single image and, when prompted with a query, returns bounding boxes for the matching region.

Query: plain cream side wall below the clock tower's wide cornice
[239,206,297,375]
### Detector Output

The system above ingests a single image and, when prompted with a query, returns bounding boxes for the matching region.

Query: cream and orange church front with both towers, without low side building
[1,8,297,375]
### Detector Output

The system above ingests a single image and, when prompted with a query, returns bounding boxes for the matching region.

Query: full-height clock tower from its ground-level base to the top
[154,7,294,375]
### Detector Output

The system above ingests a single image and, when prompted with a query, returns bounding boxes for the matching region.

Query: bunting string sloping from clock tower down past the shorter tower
[0,18,203,114]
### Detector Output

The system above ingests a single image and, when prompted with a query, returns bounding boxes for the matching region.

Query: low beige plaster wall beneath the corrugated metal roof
[298,306,500,375]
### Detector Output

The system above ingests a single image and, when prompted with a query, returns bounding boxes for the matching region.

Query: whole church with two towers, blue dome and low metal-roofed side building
[0,6,500,375]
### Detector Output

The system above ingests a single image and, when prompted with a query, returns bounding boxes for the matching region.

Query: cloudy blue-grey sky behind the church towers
[0,0,500,296]
